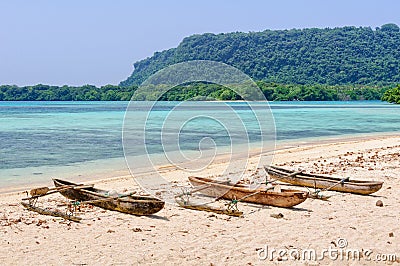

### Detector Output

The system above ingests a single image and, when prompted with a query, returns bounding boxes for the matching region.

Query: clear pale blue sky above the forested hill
[0,0,400,86]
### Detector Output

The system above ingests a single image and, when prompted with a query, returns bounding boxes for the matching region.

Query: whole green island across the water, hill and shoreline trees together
[0,24,400,103]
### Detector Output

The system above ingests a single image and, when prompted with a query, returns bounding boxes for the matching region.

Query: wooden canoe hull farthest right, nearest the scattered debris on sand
[265,166,383,195]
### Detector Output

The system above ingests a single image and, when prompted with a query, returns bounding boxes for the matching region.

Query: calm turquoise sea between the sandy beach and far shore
[0,101,400,187]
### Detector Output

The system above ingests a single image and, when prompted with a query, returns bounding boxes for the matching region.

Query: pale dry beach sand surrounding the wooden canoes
[0,136,400,265]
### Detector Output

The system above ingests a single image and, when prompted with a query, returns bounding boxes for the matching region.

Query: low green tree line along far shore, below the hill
[0,81,390,101]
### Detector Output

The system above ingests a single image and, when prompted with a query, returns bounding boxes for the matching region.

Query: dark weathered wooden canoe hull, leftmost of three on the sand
[53,179,165,215]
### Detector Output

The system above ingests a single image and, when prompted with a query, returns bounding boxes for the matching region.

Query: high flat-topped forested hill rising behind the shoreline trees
[120,24,400,86]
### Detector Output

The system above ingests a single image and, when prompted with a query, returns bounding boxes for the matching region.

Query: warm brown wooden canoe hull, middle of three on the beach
[189,176,308,208]
